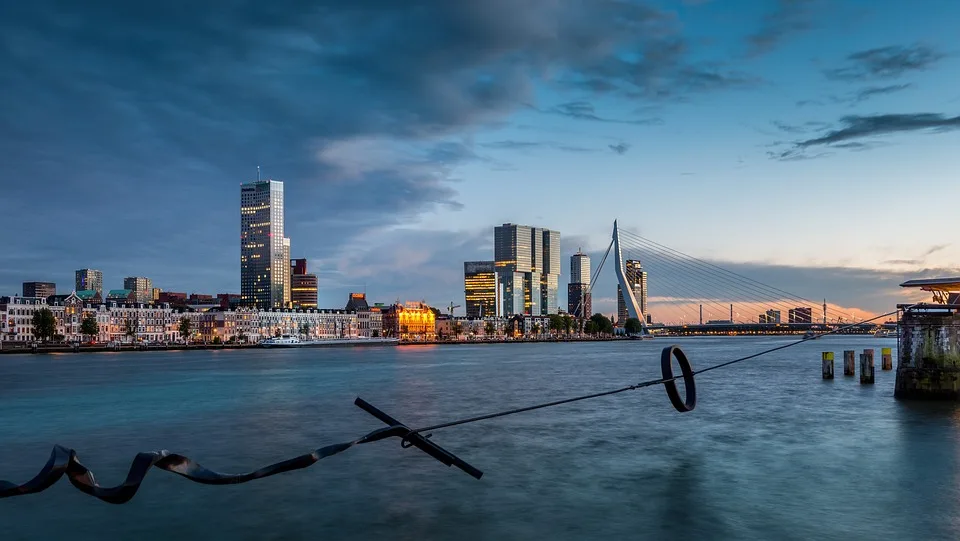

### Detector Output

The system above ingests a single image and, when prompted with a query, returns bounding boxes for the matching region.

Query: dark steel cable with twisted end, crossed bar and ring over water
[0,305,916,504]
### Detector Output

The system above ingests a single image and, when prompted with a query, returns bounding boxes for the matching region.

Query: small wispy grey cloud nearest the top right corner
[823,44,946,81]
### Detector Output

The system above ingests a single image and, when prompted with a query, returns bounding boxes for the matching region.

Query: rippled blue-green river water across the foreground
[0,337,960,541]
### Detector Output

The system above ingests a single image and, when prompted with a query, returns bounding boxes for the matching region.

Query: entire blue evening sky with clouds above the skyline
[0,0,960,313]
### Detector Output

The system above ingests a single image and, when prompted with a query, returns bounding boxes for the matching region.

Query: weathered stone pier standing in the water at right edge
[893,304,960,400]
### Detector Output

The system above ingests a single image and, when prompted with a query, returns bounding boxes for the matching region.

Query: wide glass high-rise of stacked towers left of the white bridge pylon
[493,223,560,317]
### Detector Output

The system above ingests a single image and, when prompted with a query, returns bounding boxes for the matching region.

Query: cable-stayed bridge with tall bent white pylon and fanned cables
[591,221,895,336]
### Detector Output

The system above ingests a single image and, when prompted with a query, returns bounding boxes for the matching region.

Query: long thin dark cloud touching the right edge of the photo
[768,113,960,160]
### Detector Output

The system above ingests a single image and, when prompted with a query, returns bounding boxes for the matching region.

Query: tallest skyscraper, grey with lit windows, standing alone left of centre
[240,180,290,308]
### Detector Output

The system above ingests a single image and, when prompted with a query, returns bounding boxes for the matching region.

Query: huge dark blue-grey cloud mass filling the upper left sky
[0,0,755,296]
